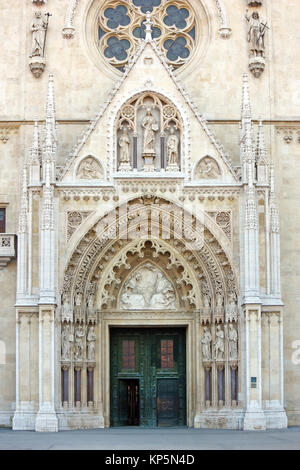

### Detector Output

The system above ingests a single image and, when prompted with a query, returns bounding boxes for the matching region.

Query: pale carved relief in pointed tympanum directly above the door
[121,263,175,310]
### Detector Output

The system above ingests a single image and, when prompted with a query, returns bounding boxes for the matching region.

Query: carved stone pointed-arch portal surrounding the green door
[61,196,240,427]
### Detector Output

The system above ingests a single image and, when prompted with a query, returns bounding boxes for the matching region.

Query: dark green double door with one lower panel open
[110,328,186,427]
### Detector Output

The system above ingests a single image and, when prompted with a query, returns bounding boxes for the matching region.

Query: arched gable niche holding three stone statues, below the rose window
[117,93,182,172]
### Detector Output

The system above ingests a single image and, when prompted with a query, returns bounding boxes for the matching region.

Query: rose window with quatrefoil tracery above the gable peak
[98,0,196,72]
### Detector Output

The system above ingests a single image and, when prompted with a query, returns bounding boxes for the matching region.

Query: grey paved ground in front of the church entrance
[0,427,300,450]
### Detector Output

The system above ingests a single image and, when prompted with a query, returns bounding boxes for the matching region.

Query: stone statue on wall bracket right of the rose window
[245,10,269,77]
